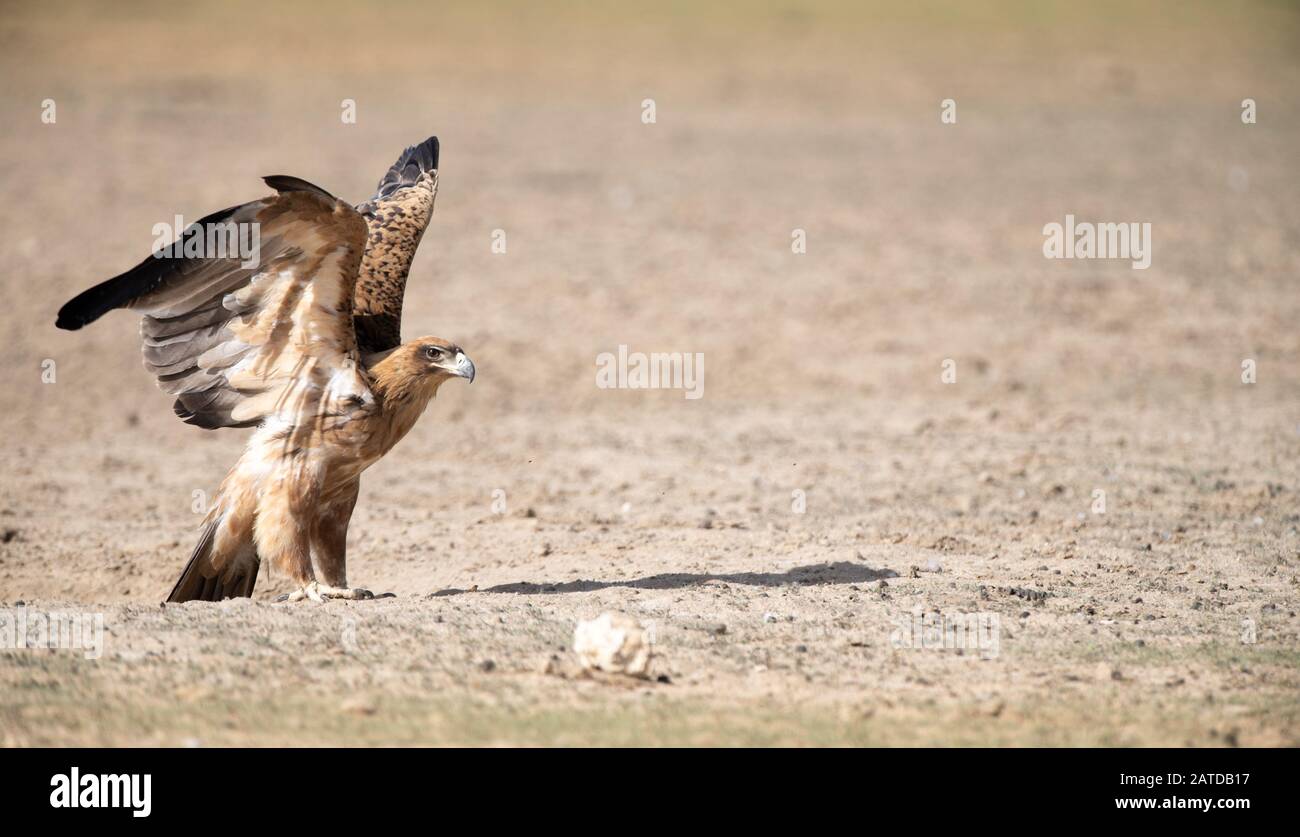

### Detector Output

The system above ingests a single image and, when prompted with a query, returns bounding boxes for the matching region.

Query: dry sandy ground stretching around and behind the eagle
[0,3,1300,746]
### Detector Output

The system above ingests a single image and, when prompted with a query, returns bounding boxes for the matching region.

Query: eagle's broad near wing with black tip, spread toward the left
[56,185,373,429]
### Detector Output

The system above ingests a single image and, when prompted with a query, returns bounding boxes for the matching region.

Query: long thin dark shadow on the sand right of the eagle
[433,561,898,595]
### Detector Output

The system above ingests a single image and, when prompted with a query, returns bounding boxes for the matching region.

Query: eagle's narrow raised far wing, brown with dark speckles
[355,136,438,354]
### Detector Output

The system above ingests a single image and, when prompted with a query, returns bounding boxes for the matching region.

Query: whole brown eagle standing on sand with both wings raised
[56,138,475,602]
